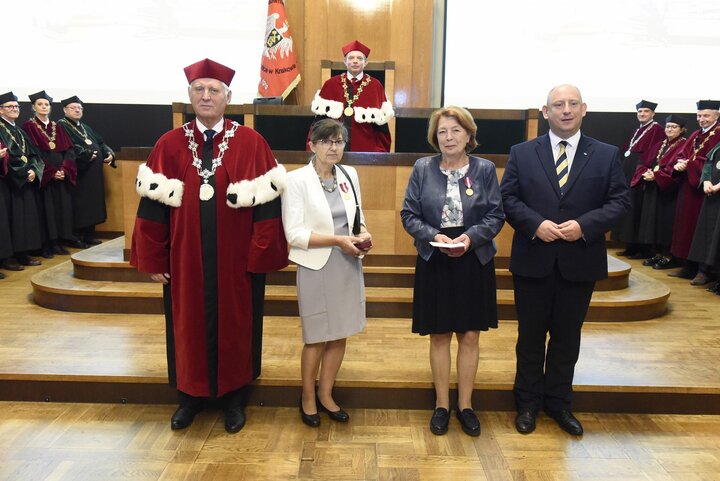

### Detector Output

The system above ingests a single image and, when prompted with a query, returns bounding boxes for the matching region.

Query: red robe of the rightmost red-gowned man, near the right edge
[670,124,720,259]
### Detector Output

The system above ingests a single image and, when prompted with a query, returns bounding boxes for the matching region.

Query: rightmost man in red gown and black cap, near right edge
[669,100,720,284]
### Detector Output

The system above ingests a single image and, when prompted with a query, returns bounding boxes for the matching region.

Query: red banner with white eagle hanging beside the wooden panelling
[258,0,300,99]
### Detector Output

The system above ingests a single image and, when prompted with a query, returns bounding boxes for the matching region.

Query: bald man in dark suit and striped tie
[500,85,630,435]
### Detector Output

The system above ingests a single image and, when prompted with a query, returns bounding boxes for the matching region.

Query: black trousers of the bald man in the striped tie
[513,265,595,411]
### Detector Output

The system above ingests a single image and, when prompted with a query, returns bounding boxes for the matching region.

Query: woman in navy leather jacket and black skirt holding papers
[400,107,505,436]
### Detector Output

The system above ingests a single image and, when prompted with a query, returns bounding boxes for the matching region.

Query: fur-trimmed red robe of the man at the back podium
[311,73,394,152]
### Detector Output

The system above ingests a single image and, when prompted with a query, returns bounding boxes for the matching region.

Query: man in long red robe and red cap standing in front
[130,59,287,433]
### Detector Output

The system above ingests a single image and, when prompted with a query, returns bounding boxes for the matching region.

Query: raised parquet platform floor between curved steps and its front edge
[0,244,720,404]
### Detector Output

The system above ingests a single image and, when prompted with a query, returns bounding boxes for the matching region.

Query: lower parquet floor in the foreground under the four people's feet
[0,403,720,481]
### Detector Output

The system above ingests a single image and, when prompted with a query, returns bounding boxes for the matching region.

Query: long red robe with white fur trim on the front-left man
[130,119,288,397]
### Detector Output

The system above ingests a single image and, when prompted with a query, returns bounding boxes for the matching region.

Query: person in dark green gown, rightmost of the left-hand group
[58,95,115,248]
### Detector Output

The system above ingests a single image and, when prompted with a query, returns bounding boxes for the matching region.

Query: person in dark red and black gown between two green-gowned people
[23,90,77,255]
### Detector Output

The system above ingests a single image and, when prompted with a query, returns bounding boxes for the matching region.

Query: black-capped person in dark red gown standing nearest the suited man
[611,100,665,259]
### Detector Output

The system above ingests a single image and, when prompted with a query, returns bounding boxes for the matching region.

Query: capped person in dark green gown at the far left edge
[0,92,43,270]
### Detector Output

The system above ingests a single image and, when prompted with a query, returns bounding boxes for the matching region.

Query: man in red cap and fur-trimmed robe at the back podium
[311,40,395,152]
